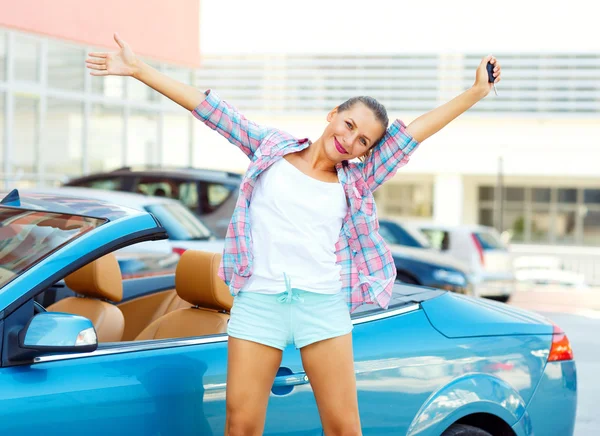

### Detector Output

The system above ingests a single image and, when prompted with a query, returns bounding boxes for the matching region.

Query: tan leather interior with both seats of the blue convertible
[38,250,233,342]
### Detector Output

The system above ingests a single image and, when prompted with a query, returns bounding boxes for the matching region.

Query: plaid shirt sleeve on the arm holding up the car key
[363,120,419,191]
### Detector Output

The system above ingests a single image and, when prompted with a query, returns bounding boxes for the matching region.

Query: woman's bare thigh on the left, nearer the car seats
[225,336,282,436]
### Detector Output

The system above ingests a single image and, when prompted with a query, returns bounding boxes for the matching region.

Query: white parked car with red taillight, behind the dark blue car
[414,223,516,302]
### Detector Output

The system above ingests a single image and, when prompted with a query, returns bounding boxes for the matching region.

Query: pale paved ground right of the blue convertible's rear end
[511,288,600,436]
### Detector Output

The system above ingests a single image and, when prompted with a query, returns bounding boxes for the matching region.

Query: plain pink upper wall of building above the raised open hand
[0,0,200,67]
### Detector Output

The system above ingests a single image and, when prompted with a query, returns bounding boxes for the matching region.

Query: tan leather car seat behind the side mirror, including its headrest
[47,254,125,342]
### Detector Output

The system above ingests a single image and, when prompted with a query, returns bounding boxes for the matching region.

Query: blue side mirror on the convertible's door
[10,312,98,361]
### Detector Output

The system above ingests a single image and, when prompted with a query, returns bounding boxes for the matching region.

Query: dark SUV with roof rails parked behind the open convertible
[65,167,242,237]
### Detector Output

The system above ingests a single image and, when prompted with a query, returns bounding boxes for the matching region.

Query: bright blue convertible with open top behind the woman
[0,191,577,436]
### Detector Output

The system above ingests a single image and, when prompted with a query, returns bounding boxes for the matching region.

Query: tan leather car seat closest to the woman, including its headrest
[135,250,233,341]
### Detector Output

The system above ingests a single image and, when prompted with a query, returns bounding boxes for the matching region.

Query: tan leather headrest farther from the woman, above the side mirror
[65,253,123,303]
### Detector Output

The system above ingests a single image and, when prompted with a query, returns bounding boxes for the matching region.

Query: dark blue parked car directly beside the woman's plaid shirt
[379,219,473,295]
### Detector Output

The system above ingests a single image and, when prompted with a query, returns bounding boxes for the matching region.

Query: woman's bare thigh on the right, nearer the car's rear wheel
[300,333,362,436]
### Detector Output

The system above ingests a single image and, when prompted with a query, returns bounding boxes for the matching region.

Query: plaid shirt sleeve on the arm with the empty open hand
[192,89,268,159]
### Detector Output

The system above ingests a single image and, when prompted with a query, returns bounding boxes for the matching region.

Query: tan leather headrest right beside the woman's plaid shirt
[175,250,233,311]
